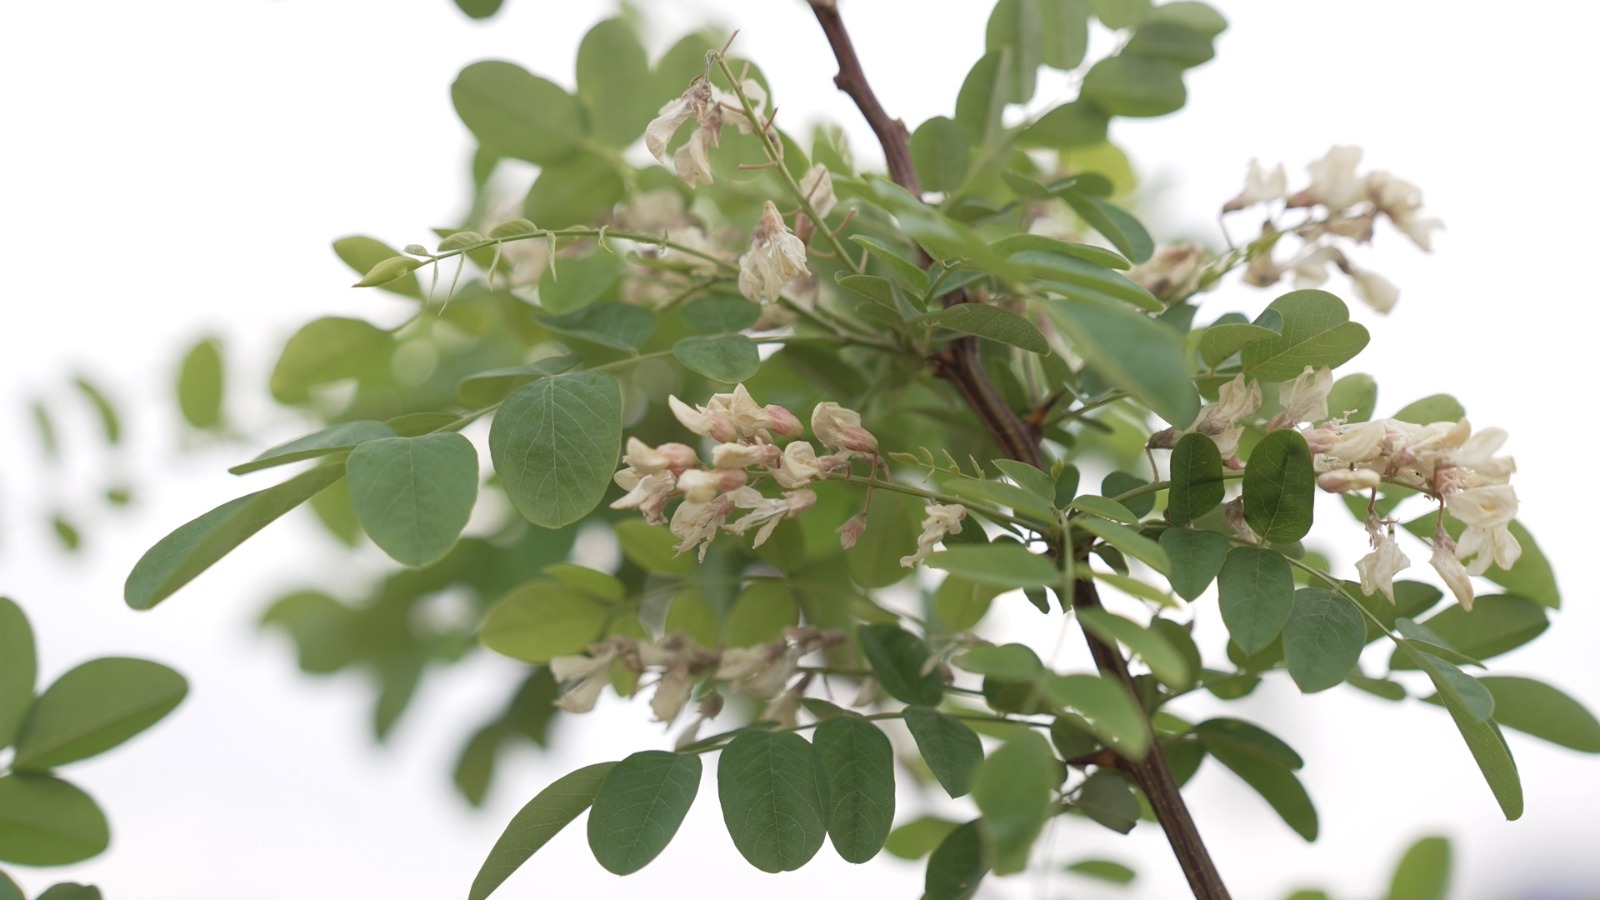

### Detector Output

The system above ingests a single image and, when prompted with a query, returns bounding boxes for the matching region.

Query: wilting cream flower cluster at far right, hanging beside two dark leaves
[1171,365,1522,609]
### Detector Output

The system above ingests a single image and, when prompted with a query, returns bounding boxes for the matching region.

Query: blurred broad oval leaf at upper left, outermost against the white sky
[450,61,584,165]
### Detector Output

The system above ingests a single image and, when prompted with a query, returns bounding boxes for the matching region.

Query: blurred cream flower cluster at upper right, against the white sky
[1222,147,1442,312]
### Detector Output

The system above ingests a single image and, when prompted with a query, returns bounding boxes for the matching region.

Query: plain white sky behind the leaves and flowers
[0,0,1600,900]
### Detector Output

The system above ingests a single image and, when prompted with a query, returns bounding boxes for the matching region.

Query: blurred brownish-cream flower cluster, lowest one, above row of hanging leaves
[550,626,845,743]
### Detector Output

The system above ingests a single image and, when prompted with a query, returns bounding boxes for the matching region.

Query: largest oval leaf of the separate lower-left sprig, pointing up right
[11,657,189,770]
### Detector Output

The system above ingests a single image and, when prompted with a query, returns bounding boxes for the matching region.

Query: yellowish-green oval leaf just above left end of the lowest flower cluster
[478,581,610,663]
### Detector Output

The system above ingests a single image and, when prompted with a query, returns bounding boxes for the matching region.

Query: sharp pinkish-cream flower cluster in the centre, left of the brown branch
[611,384,878,560]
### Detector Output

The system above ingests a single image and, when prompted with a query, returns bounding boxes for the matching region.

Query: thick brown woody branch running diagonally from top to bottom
[808,0,1229,900]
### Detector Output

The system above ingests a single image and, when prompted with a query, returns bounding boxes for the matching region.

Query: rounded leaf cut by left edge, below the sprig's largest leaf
[0,772,110,866]
